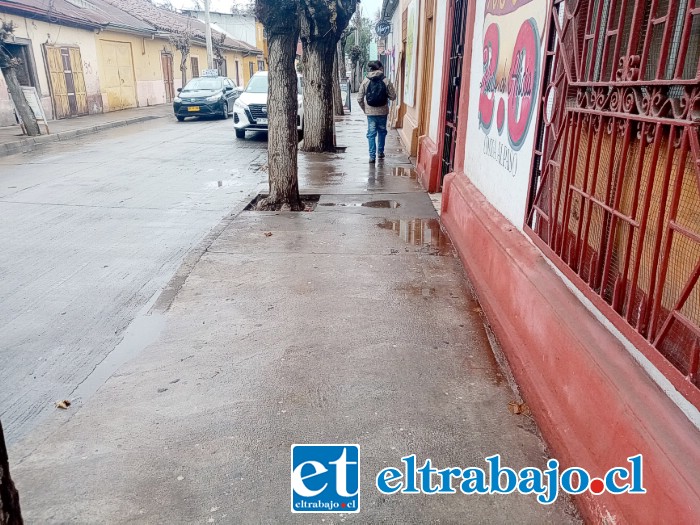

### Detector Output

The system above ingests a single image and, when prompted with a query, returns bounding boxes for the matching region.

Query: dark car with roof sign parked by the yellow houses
[173,77,241,122]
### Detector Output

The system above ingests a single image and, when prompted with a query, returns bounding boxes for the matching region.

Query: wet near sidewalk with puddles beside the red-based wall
[11,114,577,524]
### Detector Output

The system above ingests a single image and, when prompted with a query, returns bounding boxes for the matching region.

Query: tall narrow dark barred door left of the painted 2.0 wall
[442,0,467,179]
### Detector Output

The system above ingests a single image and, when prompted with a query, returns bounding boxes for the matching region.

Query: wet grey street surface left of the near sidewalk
[0,117,267,443]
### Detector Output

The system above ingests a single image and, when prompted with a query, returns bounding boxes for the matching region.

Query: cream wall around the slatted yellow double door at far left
[0,13,102,126]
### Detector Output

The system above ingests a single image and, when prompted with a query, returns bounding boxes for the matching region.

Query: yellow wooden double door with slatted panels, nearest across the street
[45,46,88,119]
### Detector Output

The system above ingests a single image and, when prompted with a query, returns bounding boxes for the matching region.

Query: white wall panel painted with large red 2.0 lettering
[466,0,547,226]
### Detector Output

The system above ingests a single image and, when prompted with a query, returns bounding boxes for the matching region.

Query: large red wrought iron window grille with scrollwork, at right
[526,0,700,405]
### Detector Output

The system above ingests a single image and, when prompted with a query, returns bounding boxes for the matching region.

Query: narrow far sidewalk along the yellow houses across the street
[0,104,173,157]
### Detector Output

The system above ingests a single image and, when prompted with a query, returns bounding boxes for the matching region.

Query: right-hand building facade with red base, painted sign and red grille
[400,0,700,523]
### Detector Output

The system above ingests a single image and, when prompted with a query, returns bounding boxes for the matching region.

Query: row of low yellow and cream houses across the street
[0,0,265,126]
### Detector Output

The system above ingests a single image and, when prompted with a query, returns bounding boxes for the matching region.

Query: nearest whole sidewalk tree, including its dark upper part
[255,0,302,211]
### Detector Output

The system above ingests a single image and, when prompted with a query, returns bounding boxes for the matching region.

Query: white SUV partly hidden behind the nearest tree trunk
[233,71,304,139]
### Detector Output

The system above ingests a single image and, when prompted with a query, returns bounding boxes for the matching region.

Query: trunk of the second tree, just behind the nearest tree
[303,37,337,152]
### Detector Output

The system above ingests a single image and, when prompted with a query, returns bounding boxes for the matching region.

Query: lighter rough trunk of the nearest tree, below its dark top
[257,30,306,211]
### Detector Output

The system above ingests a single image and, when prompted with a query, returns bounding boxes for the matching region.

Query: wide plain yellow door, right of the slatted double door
[101,40,136,111]
